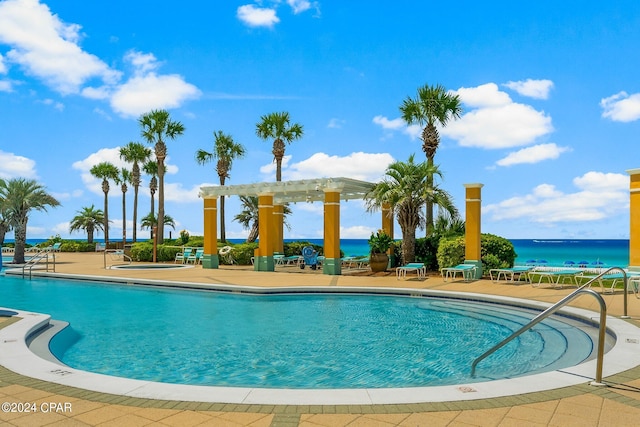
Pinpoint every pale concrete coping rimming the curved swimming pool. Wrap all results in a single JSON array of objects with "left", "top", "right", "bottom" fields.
[{"left": 0, "top": 273, "right": 640, "bottom": 405}]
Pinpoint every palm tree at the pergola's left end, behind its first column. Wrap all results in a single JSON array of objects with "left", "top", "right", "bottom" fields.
[{"left": 196, "top": 131, "right": 245, "bottom": 242}]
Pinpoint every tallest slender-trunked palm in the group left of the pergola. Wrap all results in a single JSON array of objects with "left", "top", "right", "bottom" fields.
[{"left": 138, "top": 110, "right": 184, "bottom": 243}]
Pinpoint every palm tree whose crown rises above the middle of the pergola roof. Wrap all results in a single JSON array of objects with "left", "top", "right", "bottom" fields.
[{"left": 256, "top": 112, "right": 303, "bottom": 182}]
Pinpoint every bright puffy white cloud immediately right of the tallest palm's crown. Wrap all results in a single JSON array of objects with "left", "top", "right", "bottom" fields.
[{"left": 440, "top": 83, "right": 553, "bottom": 149}]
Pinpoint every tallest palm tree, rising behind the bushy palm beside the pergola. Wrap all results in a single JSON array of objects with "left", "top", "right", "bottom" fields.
[{"left": 400, "top": 85, "right": 462, "bottom": 235}]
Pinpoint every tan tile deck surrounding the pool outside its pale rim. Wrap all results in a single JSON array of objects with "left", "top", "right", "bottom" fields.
[{"left": 0, "top": 253, "right": 640, "bottom": 426}]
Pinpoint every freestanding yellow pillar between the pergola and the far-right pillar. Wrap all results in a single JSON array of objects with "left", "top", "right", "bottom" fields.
[{"left": 464, "top": 184, "right": 483, "bottom": 279}]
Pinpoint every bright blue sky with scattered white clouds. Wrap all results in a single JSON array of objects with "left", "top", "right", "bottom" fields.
[{"left": 0, "top": 0, "right": 640, "bottom": 239}]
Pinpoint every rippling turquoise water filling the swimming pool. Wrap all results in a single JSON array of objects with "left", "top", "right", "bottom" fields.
[{"left": 0, "top": 276, "right": 596, "bottom": 388}]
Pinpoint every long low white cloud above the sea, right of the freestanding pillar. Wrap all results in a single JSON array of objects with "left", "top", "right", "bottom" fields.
[{"left": 483, "top": 172, "right": 629, "bottom": 224}]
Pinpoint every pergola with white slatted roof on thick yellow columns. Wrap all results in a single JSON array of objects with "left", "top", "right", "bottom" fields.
[{"left": 200, "top": 178, "right": 393, "bottom": 275}]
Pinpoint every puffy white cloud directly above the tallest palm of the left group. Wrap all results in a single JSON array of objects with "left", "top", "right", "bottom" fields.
[{"left": 107, "top": 52, "right": 201, "bottom": 117}]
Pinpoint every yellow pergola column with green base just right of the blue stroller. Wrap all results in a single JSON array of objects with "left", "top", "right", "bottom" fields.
[{"left": 322, "top": 190, "right": 342, "bottom": 275}]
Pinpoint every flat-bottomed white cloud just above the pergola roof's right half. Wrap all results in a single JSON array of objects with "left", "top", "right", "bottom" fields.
[{"left": 276, "top": 152, "right": 394, "bottom": 182}]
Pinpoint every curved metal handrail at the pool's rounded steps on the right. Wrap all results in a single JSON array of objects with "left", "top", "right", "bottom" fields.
[{"left": 471, "top": 267, "right": 628, "bottom": 386}]
